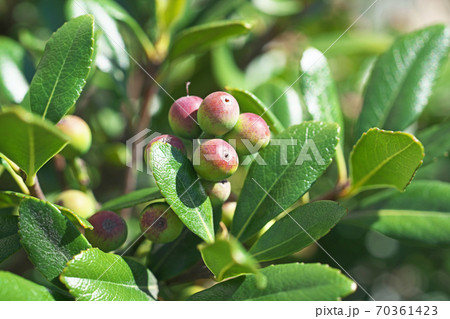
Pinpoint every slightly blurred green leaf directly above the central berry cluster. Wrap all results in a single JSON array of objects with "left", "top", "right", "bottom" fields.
[{"left": 169, "top": 21, "right": 252, "bottom": 59}]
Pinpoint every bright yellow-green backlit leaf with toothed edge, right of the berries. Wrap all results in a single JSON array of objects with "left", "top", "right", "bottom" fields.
[{"left": 349, "top": 128, "right": 425, "bottom": 193}]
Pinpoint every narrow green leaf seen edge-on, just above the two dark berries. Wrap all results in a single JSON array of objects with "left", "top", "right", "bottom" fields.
[{"left": 102, "top": 187, "right": 162, "bottom": 210}]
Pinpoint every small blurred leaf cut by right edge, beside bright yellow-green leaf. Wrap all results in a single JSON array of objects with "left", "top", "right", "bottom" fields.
[{"left": 417, "top": 122, "right": 450, "bottom": 166}]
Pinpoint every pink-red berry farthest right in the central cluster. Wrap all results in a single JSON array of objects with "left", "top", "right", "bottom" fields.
[{"left": 224, "top": 113, "right": 270, "bottom": 156}]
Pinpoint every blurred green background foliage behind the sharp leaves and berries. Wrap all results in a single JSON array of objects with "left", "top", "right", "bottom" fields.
[{"left": 0, "top": 0, "right": 450, "bottom": 300}]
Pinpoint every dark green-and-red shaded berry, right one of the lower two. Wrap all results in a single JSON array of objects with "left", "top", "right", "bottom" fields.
[{"left": 139, "top": 203, "right": 184, "bottom": 243}]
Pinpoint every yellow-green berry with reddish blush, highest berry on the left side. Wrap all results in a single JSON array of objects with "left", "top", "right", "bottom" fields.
[{"left": 56, "top": 115, "right": 92, "bottom": 159}]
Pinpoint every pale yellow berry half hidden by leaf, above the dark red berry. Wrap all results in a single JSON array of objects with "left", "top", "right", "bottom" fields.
[{"left": 55, "top": 189, "right": 96, "bottom": 218}]
